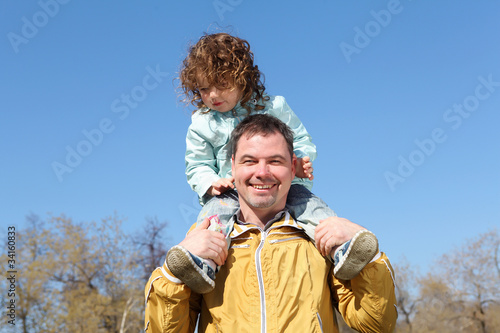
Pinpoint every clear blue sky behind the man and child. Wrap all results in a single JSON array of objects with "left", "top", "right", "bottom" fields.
[{"left": 0, "top": 0, "right": 500, "bottom": 269}]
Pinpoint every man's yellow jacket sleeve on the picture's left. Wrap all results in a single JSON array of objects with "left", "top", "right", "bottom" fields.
[{"left": 144, "top": 264, "right": 201, "bottom": 333}]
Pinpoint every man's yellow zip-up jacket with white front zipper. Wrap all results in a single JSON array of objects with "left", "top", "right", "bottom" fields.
[{"left": 145, "top": 213, "right": 397, "bottom": 333}]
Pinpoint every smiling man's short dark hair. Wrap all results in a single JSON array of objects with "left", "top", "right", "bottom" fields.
[{"left": 230, "top": 114, "right": 293, "bottom": 158}]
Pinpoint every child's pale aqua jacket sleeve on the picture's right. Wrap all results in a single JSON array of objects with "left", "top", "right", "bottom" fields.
[{"left": 270, "top": 96, "right": 317, "bottom": 161}]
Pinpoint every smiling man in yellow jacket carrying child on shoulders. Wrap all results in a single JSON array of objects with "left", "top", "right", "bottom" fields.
[{"left": 145, "top": 115, "right": 397, "bottom": 332}]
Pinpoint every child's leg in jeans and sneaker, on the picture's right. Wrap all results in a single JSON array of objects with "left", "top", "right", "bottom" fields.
[{"left": 287, "top": 184, "right": 378, "bottom": 280}]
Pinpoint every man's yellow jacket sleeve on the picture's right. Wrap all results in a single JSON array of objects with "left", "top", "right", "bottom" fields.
[{"left": 333, "top": 253, "right": 398, "bottom": 332}]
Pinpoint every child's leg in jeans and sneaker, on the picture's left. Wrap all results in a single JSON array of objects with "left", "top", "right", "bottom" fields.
[{"left": 167, "top": 190, "right": 239, "bottom": 294}]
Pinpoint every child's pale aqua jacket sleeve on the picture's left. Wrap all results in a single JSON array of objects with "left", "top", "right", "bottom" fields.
[{"left": 185, "top": 124, "right": 220, "bottom": 198}]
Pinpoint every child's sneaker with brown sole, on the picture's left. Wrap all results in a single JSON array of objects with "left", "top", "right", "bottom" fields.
[{"left": 167, "top": 245, "right": 215, "bottom": 294}]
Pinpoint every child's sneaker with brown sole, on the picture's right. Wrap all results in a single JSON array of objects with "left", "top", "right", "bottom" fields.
[{"left": 332, "top": 230, "right": 378, "bottom": 280}]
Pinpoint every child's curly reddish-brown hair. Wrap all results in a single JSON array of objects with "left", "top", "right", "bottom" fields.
[{"left": 179, "top": 33, "right": 265, "bottom": 113}]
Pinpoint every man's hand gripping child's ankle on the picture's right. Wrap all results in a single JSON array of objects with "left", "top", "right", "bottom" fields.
[{"left": 314, "top": 216, "right": 366, "bottom": 256}]
